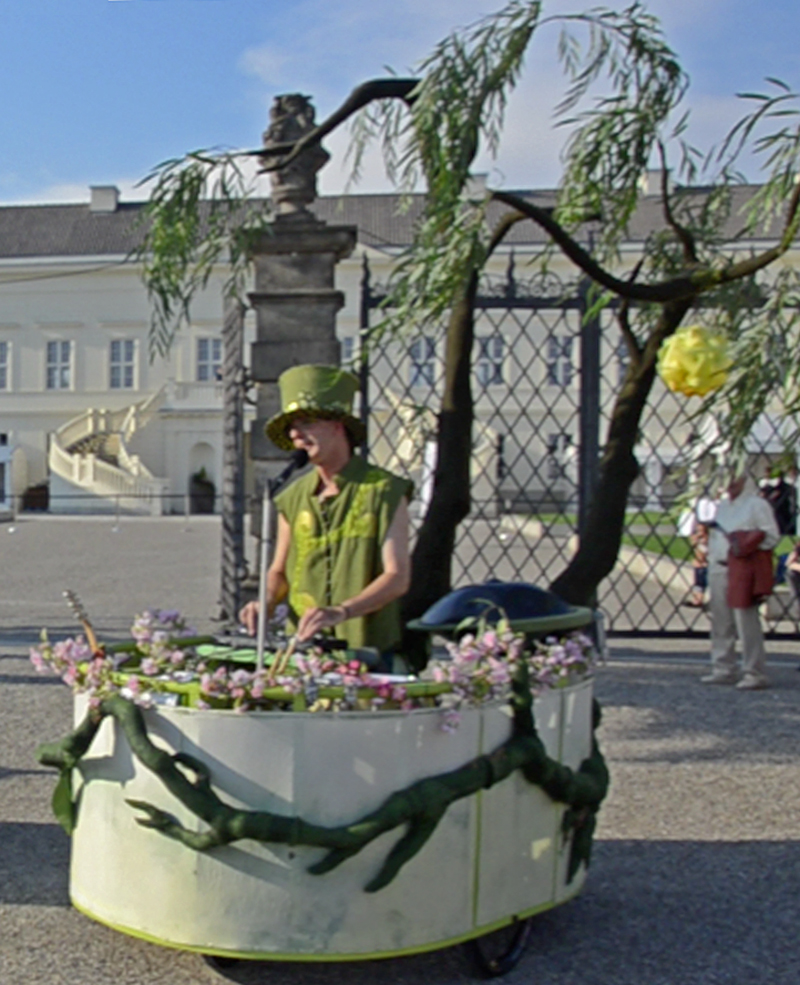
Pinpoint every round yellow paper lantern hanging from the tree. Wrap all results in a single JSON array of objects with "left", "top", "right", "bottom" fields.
[{"left": 657, "top": 325, "right": 732, "bottom": 397}]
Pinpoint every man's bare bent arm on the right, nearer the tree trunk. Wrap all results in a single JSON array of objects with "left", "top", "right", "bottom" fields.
[{"left": 297, "top": 497, "right": 411, "bottom": 640}]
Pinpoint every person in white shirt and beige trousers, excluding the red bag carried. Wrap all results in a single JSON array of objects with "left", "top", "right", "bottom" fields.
[{"left": 701, "top": 475, "right": 780, "bottom": 691}]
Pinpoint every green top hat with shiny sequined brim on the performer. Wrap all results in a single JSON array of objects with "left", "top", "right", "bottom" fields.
[{"left": 265, "top": 366, "right": 366, "bottom": 451}]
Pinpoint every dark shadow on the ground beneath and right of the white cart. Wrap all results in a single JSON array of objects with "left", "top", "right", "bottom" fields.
[{"left": 111, "top": 841, "right": 800, "bottom": 985}]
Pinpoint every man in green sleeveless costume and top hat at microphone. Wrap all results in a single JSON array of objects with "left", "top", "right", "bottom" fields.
[{"left": 240, "top": 366, "right": 413, "bottom": 654}]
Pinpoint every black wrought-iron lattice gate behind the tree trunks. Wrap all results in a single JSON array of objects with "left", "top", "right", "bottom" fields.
[{"left": 354, "top": 255, "right": 800, "bottom": 636}]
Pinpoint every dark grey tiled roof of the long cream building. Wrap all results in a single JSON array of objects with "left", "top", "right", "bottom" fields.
[{"left": 0, "top": 185, "right": 788, "bottom": 259}]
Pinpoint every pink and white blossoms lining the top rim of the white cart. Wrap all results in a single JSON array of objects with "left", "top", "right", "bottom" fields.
[{"left": 30, "top": 609, "right": 596, "bottom": 731}]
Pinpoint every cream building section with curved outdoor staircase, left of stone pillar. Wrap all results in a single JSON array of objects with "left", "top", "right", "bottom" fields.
[{"left": 0, "top": 187, "right": 253, "bottom": 513}]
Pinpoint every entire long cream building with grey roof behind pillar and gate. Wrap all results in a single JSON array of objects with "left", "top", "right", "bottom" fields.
[{"left": 0, "top": 181, "right": 795, "bottom": 513}]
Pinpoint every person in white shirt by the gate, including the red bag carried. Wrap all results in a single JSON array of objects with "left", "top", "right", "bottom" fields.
[{"left": 701, "top": 475, "right": 779, "bottom": 691}]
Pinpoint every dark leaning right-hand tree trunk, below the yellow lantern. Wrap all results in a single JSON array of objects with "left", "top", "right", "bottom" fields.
[{"left": 550, "top": 299, "right": 692, "bottom": 606}]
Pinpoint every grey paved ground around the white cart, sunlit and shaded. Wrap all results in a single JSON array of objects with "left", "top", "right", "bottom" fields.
[{"left": 0, "top": 518, "right": 800, "bottom": 985}]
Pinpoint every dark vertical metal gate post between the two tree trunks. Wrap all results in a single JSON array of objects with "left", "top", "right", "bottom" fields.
[{"left": 578, "top": 281, "right": 600, "bottom": 536}]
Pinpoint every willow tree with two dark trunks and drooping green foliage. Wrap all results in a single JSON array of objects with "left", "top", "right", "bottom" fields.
[{"left": 134, "top": 0, "right": 800, "bottom": 617}]
